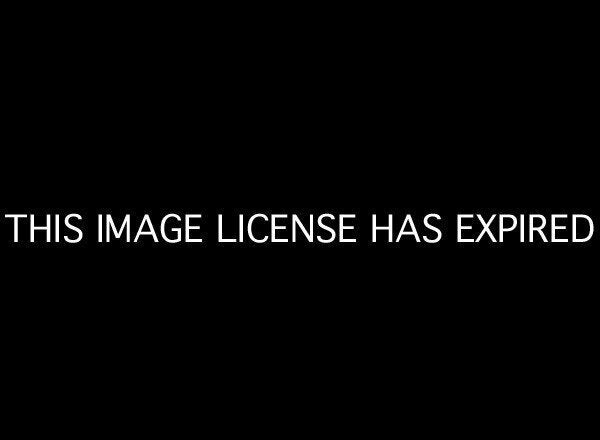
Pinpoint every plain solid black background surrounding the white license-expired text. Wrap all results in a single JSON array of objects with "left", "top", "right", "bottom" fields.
[{"left": 1, "top": 5, "right": 598, "bottom": 433}]
